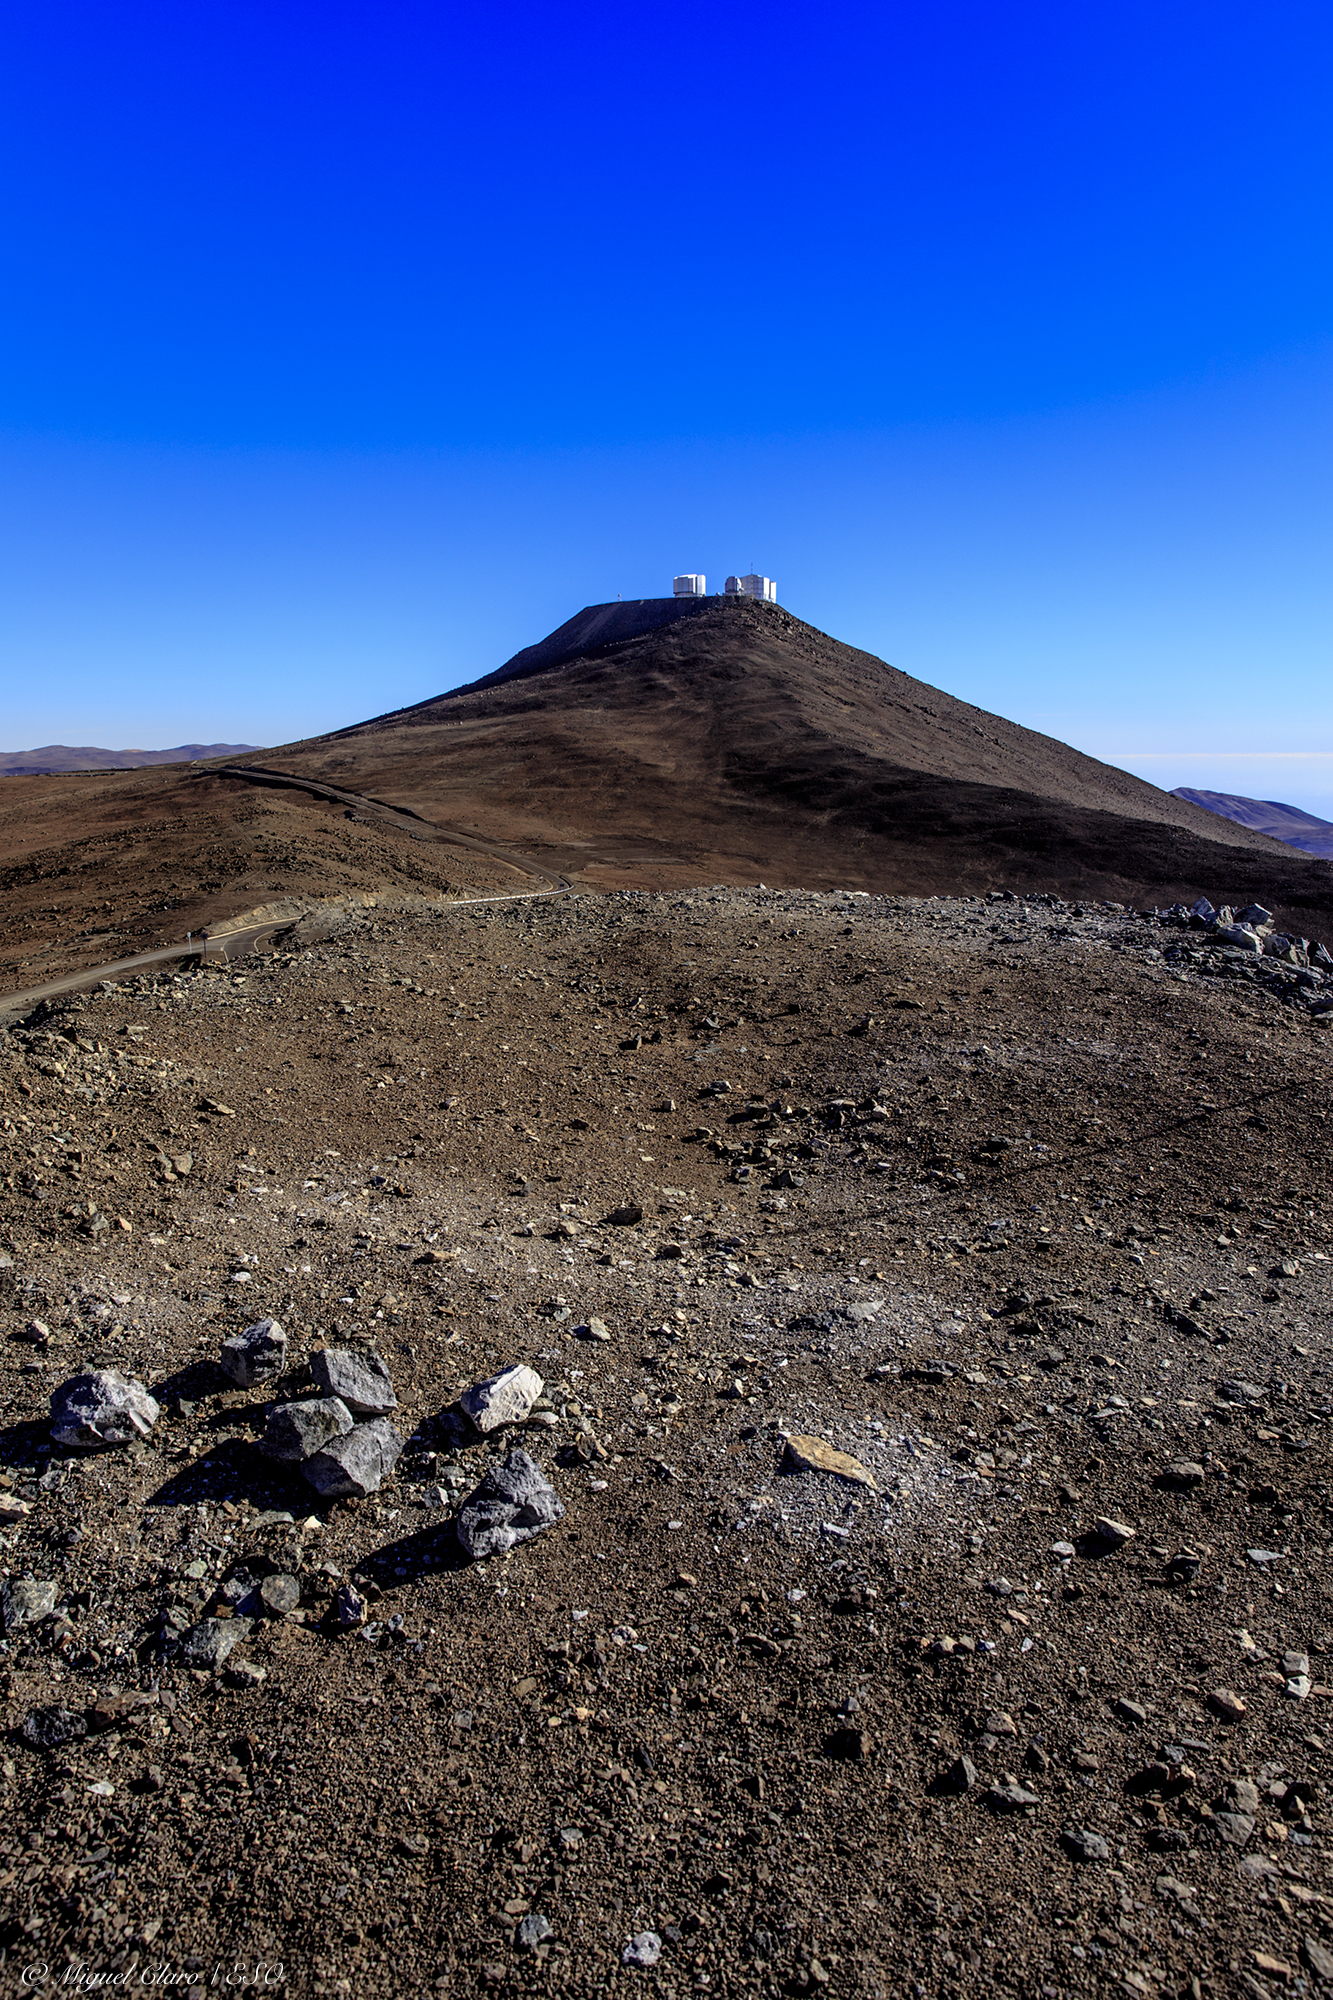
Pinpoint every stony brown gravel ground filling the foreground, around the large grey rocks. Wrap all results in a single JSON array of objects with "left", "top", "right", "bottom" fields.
[{"left": 0, "top": 882, "right": 1333, "bottom": 2000}]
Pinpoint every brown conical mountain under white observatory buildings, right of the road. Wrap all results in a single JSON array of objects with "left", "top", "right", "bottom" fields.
[{"left": 233, "top": 598, "right": 1333, "bottom": 912}]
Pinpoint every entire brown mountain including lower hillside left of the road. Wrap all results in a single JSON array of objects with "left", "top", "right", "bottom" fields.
[{"left": 0, "top": 598, "right": 1333, "bottom": 984}]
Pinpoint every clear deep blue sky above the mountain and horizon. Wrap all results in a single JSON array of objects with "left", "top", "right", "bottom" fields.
[{"left": 0, "top": 0, "right": 1333, "bottom": 818}]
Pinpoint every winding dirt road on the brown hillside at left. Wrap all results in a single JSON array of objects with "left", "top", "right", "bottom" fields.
[{"left": 0, "top": 764, "right": 574, "bottom": 1028}]
